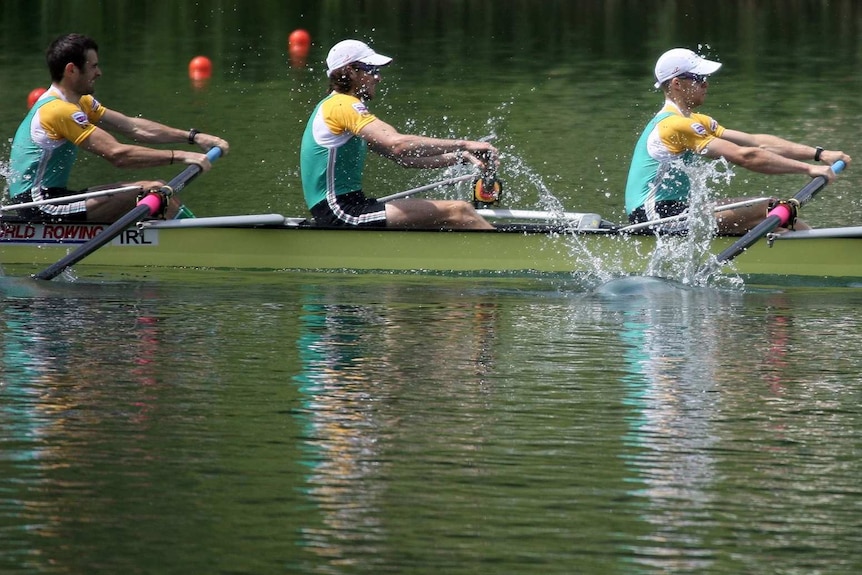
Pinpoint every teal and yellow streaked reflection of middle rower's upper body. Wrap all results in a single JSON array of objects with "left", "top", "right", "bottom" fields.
[{"left": 298, "top": 292, "right": 392, "bottom": 564}]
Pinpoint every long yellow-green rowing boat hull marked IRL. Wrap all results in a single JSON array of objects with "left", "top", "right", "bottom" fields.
[{"left": 0, "top": 210, "right": 862, "bottom": 284}]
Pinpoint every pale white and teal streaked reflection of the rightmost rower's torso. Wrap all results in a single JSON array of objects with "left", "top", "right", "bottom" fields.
[{"left": 615, "top": 284, "right": 721, "bottom": 571}]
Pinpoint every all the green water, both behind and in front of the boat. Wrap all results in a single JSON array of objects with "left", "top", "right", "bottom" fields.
[{"left": 0, "top": 0, "right": 862, "bottom": 575}]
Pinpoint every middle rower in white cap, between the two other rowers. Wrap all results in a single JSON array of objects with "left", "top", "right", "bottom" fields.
[{"left": 300, "top": 40, "right": 498, "bottom": 229}]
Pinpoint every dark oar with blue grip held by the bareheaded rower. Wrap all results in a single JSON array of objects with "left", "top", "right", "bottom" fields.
[{"left": 32, "top": 147, "right": 222, "bottom": 280}]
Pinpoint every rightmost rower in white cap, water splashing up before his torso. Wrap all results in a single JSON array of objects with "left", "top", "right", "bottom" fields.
[{"left": 626, "top": 48, "right": 850, "bottom": 235}]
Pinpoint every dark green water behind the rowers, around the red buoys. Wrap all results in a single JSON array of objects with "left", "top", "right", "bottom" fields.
[{"left": 0, "top": 0, "right": 862, "bottom": 225}]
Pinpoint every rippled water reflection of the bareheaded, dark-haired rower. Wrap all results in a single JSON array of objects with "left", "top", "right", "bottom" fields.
[{"left": 0, "top": 278, "right": 174, "bottom": 571}]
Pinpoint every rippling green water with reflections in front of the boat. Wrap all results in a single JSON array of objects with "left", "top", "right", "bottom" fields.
[{"left": 5, "top": 272, "right": 862, "bottom": 573}]
